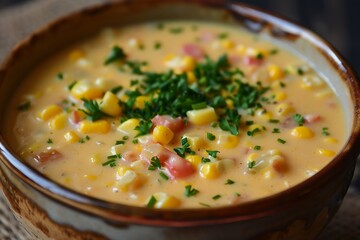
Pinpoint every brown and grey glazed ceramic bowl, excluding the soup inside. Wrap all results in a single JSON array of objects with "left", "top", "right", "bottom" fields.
[{"left": 0, "top": 0, "right": 360, "bottom": 240}]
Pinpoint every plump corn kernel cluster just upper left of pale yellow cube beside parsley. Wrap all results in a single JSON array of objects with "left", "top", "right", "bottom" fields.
[{"left": 70, "top": 80, "right": 103, "bottom": 99}]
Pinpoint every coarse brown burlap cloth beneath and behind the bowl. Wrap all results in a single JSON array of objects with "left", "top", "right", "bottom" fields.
[{"left": 0, "top": 0, "right": 360, "bottom": 240}]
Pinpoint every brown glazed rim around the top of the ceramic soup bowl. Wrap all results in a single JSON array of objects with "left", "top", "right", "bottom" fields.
[{"left": 0, "top": 0, "right": 360, "bottom": 227}]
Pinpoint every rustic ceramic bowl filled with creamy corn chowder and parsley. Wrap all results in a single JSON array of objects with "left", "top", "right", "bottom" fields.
[{"left": 0, "top": 0, "right": 360, "bottom": 239}]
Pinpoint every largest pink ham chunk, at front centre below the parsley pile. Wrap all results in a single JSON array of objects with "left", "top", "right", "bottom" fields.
[{"left": 140, "top": 144, "right": 195, "bottom": 179}]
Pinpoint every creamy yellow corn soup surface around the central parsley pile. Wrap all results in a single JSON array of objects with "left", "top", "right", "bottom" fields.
[{"left": 9, "top": 21, "right": 345, "bottom": 208}]
